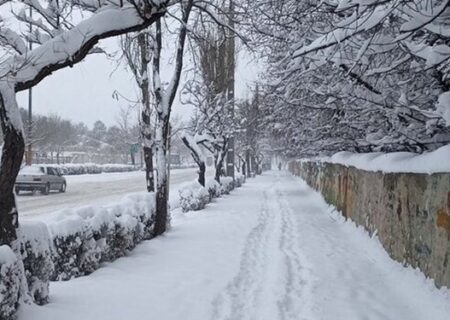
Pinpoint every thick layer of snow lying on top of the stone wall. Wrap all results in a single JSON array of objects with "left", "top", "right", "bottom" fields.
[{"left": 308, "top": 145, "right": 450, "bottom": 174}]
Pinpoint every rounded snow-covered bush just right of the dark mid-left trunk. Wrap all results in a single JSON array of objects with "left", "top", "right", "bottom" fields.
[{"left": 178, "top": 181, "right": 211, "bottom": 212}]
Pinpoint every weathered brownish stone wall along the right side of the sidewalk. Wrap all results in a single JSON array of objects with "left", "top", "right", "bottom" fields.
[{"left": 289, "top": 159, "right": 450, "bottom": 288}]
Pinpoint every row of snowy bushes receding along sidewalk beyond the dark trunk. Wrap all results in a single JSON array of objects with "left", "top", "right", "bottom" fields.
[{"left": 178, "top": 174, "right": 245, "bottom": 212}]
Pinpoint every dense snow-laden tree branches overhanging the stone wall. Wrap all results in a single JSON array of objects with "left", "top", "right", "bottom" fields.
[{"left": 243, "top": 0, "right": 450, "bottom": 156}]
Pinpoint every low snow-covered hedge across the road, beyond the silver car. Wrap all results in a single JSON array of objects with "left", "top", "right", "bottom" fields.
[{"left": 39, "top": 163, "right": 139, "bottom": 175}]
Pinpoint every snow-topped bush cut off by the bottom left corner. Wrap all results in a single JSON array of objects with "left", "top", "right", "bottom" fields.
[{"left": 0, "top": 246, "right": 23, "bottom": 320}]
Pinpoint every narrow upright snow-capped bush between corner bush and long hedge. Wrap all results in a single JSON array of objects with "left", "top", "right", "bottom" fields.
[{"left": 17, "top": 221, "right": 54, "bottom": 305}]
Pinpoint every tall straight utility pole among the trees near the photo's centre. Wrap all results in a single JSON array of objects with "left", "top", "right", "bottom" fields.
[{"left": 226, "top": 0, "right": 236, "bottom": 180}]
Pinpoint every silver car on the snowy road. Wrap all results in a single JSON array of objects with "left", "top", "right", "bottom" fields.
[{"left": 15, "top": 165, "right": 67, "bottom": 195}]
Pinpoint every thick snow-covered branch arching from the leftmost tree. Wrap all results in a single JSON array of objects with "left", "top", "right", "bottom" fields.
[{"left": 0, "top": 0, "right": 169, "bottom": 92}]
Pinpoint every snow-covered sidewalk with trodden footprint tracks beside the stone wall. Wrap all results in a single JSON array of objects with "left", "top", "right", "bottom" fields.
[{"left": 19, "top": 172, "right": 450, "bottom": 320}]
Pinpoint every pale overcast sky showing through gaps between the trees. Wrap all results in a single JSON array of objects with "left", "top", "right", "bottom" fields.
[{"left": 14, "top": 39, "right": 259, "bottom": 126}]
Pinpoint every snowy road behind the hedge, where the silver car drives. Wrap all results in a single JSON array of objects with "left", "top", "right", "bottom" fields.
[{"left": 16, "top": 169, "right": 202, "bottom": 218}]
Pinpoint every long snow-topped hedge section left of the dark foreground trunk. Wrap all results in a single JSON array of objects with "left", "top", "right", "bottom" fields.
[{"left": 50, "top": 194, "right": 155, "bottom": 280}]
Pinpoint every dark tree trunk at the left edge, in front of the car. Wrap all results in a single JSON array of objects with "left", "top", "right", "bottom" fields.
[{"left": 0, "top": 92, "right": 25, "bottom": 246}]
